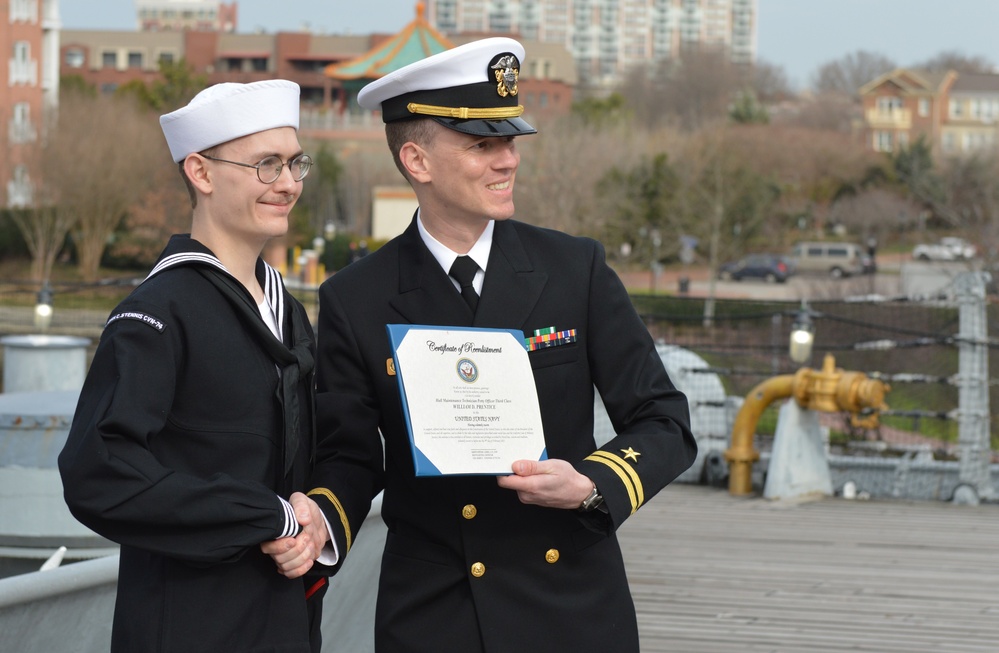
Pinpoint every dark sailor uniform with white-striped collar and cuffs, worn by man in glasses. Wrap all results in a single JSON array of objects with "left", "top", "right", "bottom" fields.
[{"left": 59, "top": 236, "right": 322, "bottom": 653}]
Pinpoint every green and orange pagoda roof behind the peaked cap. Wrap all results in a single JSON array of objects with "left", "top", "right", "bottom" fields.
[{"left": 325, "top": 2, "right": 454, "bottom": 80}]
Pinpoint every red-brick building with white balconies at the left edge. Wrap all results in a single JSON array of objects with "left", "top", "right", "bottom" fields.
[{"left": 0, "top": 0, "right": 59, "bottom": 208}]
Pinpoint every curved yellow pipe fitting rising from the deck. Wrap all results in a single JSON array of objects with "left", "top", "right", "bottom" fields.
[{"left": 725, "top": 354, "right": 891, "bottom": 495}]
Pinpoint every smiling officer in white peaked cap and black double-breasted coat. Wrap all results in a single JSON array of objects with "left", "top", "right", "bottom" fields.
[{"left": 316, "top": 38, "right": 696, "bottom": 653}]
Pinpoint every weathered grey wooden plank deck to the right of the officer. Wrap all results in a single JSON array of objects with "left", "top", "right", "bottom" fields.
[{"left": 619, "top": 484, "right": 999, "bottom": 653}]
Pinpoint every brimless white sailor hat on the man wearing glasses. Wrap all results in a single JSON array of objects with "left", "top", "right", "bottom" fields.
[{"left": 160, "top": 79, "right": 299, "bottom": 163}]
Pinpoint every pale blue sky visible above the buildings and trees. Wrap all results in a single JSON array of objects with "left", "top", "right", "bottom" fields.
[{"left": 60, "top": 0, "right": 999, "bottom": 88}]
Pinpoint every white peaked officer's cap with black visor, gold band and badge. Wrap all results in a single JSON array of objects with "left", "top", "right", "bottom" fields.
[{"left": 357, "top": 37, "right": 538, "bottom": 136}]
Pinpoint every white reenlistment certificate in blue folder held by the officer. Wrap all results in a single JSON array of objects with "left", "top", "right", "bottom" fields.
[{"left": 387, "top": 324, "right": 548, "bottom": 476}]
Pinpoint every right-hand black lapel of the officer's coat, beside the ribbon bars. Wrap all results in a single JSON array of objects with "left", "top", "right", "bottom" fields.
[{"left": 475, "top": 220, "right": 548, "bottom": 328}]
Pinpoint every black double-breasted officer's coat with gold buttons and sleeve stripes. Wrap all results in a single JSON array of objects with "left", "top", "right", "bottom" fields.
[{"left": 313, "top": 220, "right": 696, "bottom": 653}]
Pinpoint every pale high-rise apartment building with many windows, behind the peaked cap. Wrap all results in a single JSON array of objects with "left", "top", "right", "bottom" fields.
[{"left": 428, "top": 0, "right": 756, "bottom": 87}]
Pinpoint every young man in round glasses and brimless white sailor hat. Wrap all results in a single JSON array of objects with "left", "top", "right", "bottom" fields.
[{"left": 59, "top": 80, "right": 339, "bottom": 653}]
